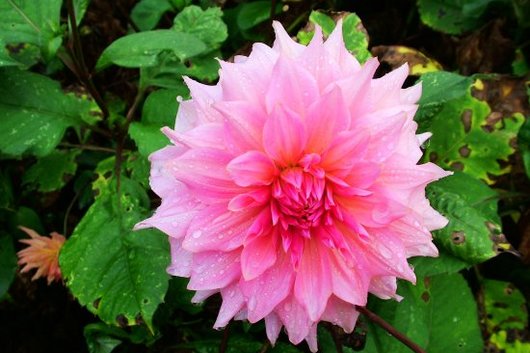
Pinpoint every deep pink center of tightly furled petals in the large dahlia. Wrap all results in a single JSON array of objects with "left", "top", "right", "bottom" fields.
[{"left": 271, "top": 167, "right": 333, "bottom": 234}]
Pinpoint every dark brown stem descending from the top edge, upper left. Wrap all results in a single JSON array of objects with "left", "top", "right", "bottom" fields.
[{"left": 63, "top": 0, "right": 109, "bottom": 118}]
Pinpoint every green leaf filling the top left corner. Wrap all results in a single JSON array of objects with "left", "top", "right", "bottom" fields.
[{"left": 0, "top": 0, "right": 62, "bottom": 61}]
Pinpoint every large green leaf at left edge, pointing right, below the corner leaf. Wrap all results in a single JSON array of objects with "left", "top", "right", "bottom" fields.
[{"left": 0, "top": 68, "right": 92, "bottom": 157}]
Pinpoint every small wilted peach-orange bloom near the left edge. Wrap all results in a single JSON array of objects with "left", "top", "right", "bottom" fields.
[{"left": 17, "top": 226, "right": 66, "bottom": 284}]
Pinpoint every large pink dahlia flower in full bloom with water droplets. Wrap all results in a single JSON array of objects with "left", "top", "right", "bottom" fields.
[{"left": 137, "top": 23, "right": 448, "bottom": 351}]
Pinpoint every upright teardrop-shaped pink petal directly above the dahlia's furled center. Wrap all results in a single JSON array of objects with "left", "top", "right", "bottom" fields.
[{"left": 263, "top": 106, "right": 307, "bottom": 166}]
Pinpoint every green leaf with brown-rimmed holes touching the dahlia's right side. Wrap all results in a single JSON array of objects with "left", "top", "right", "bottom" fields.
[{"left": 427, "top": 173, "right": 512, "bottom": 264}]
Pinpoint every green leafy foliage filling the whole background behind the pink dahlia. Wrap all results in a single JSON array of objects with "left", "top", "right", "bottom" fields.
[{"left": 0, "top": 0, "right": 530, "bottom": 353}]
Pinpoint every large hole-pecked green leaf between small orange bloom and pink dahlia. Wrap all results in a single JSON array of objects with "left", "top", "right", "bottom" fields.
[{"left": 59, "top": 177, "right": 169, "bottom": 331}]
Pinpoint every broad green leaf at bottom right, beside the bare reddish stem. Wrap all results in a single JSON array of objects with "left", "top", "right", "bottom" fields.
[{"left": 363, "top": 274, "right": 483, "bottom": 353}]
